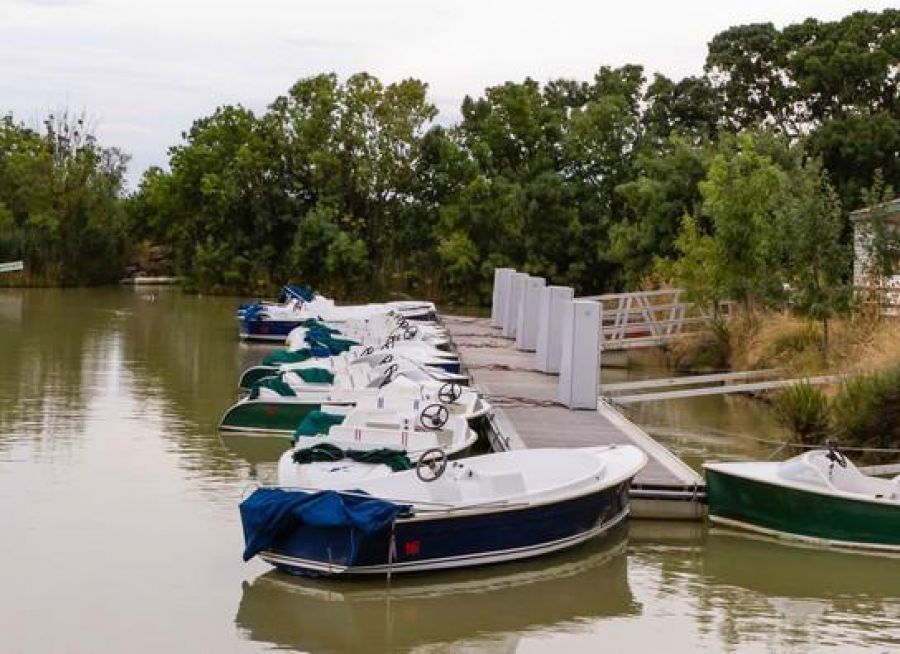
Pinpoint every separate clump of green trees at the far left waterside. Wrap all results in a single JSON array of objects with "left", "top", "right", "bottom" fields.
[{"left": 0, "top": 111, "right": 128, "bottom": 285}]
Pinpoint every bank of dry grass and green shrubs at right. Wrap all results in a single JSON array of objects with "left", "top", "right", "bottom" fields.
[{"left": 668, "top": 312, "right": 900, "bottom": 461}]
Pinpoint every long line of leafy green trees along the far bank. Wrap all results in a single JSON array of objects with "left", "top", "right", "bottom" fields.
[{"left": 0, "top": 10, "right": 900, "bottom": 302}]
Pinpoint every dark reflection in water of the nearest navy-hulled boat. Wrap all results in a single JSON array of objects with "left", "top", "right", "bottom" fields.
[{"left": 235, "top": 526, "right": 640, "bottom": 651}]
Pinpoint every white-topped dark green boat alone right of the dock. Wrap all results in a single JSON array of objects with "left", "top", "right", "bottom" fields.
[{"left": 704, "top": 449, "right": 900, "bottom": 552}]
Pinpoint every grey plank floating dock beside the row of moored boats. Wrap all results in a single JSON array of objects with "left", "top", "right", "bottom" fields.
[{"left": 442, "top": 316, "right": 705, "bottom": 519}]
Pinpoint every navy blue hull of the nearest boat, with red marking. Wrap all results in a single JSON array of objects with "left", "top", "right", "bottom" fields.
[{"left": 260, "top": 481, "right": 628, "bottom": 575}]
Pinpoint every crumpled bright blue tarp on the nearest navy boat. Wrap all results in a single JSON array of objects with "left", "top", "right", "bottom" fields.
[{"left": 241, "top": 488, "right": 409, "bottom": 561}]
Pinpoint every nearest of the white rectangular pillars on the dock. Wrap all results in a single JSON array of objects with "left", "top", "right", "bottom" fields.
[{"left": 559, "top": 301, "right": 602, "bottom": 410}]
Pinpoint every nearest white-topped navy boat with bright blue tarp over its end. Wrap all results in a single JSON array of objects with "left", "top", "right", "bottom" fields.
[{"left": 241, "top": 445, "right": 647, "bottom": 575}]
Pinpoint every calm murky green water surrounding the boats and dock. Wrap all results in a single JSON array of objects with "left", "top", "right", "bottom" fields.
[{"left": 0, "top": 289, "right": 900, "bottom": 654}]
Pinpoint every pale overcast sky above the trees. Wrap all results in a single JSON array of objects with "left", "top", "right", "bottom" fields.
[{"left": 0, "top": 0, "right": 892, "bottom": 180}]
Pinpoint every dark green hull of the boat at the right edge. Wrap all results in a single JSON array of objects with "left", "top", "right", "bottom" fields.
[{"left": 706, "top": 468, "right": 900, "bottom": 551}]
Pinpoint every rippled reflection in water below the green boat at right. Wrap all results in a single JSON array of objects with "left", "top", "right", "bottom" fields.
[{"left": 701, "top": 528, "right": 900, "bottom": 651}]
